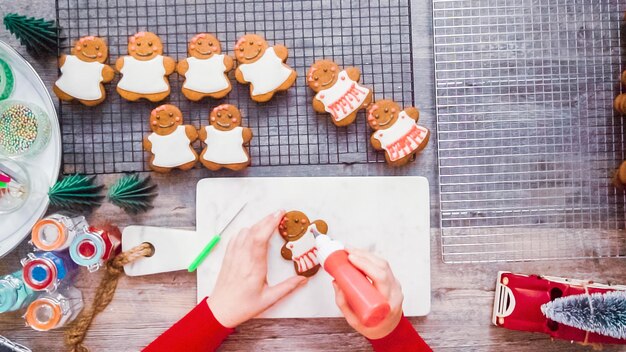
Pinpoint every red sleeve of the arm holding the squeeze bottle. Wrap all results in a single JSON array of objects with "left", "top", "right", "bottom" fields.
[{"left": 368, "top": 316, "right": 432, "bottom": 352}]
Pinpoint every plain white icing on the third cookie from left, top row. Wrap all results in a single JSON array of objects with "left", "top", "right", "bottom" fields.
[{"left": 183, "top": 54, "right": 228, "bottom": 94}]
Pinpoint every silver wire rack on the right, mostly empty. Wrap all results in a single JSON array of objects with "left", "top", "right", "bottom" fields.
[{"left": 433, "top": 0, "right": 626, "bottom": 263}]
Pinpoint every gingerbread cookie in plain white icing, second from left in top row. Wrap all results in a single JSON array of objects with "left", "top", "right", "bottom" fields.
[{"left": 115, "top": 32, "right": 176, "bottom": 102}]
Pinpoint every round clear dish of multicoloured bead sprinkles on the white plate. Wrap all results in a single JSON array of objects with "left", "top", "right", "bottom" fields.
[{"left": 0, "top": 100, "right": 50, "bottom": 157}]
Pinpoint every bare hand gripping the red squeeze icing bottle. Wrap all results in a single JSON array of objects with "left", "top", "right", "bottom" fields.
[{"left": 333, "top": 248, "right": 404, "bottom": 340}]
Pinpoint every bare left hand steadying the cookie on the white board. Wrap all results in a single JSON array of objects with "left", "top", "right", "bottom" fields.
[{"left": 207, "top": 210, "right": 307, "bottom": 328}]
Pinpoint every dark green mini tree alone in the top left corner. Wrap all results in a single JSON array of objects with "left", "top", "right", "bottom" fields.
[{"left": 3, "top": 13, "right": 63, "bottom": 55}]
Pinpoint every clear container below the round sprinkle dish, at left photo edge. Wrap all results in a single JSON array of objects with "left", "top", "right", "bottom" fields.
[{"left": 0, "top": 157, "right": 32, "bottom": 214}]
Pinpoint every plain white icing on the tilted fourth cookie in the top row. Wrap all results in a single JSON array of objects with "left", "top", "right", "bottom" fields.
[{"left": 239, "top": 47, "right": 293, "bottom": 95}]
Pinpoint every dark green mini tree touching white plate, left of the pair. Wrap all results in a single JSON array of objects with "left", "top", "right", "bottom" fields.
[{"left": 48, "top": 174, "right": 104, "bottom": 209}]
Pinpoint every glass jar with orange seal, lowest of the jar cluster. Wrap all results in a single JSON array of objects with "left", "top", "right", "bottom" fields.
[{"left": 24, "top": 286, "right": 83, "bottom": 331}]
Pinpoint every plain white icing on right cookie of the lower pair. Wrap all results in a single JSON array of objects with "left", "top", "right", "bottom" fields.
[{"left": 203, "top": 126, "right": 248, "bottom": 165}]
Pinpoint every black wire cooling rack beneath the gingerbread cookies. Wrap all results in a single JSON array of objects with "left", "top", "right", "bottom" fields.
[{"left": 56, "top": 0, "right": 413, "bottom": 174}]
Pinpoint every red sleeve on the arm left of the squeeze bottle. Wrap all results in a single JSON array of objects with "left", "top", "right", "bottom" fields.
[{"left": 143, "top": 298, "right": 235, "bottom": 352}]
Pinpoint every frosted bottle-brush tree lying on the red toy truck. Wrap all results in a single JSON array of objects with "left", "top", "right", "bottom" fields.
[{"left": 541, "top": 291, "right": 626, "bottom": 339}]
